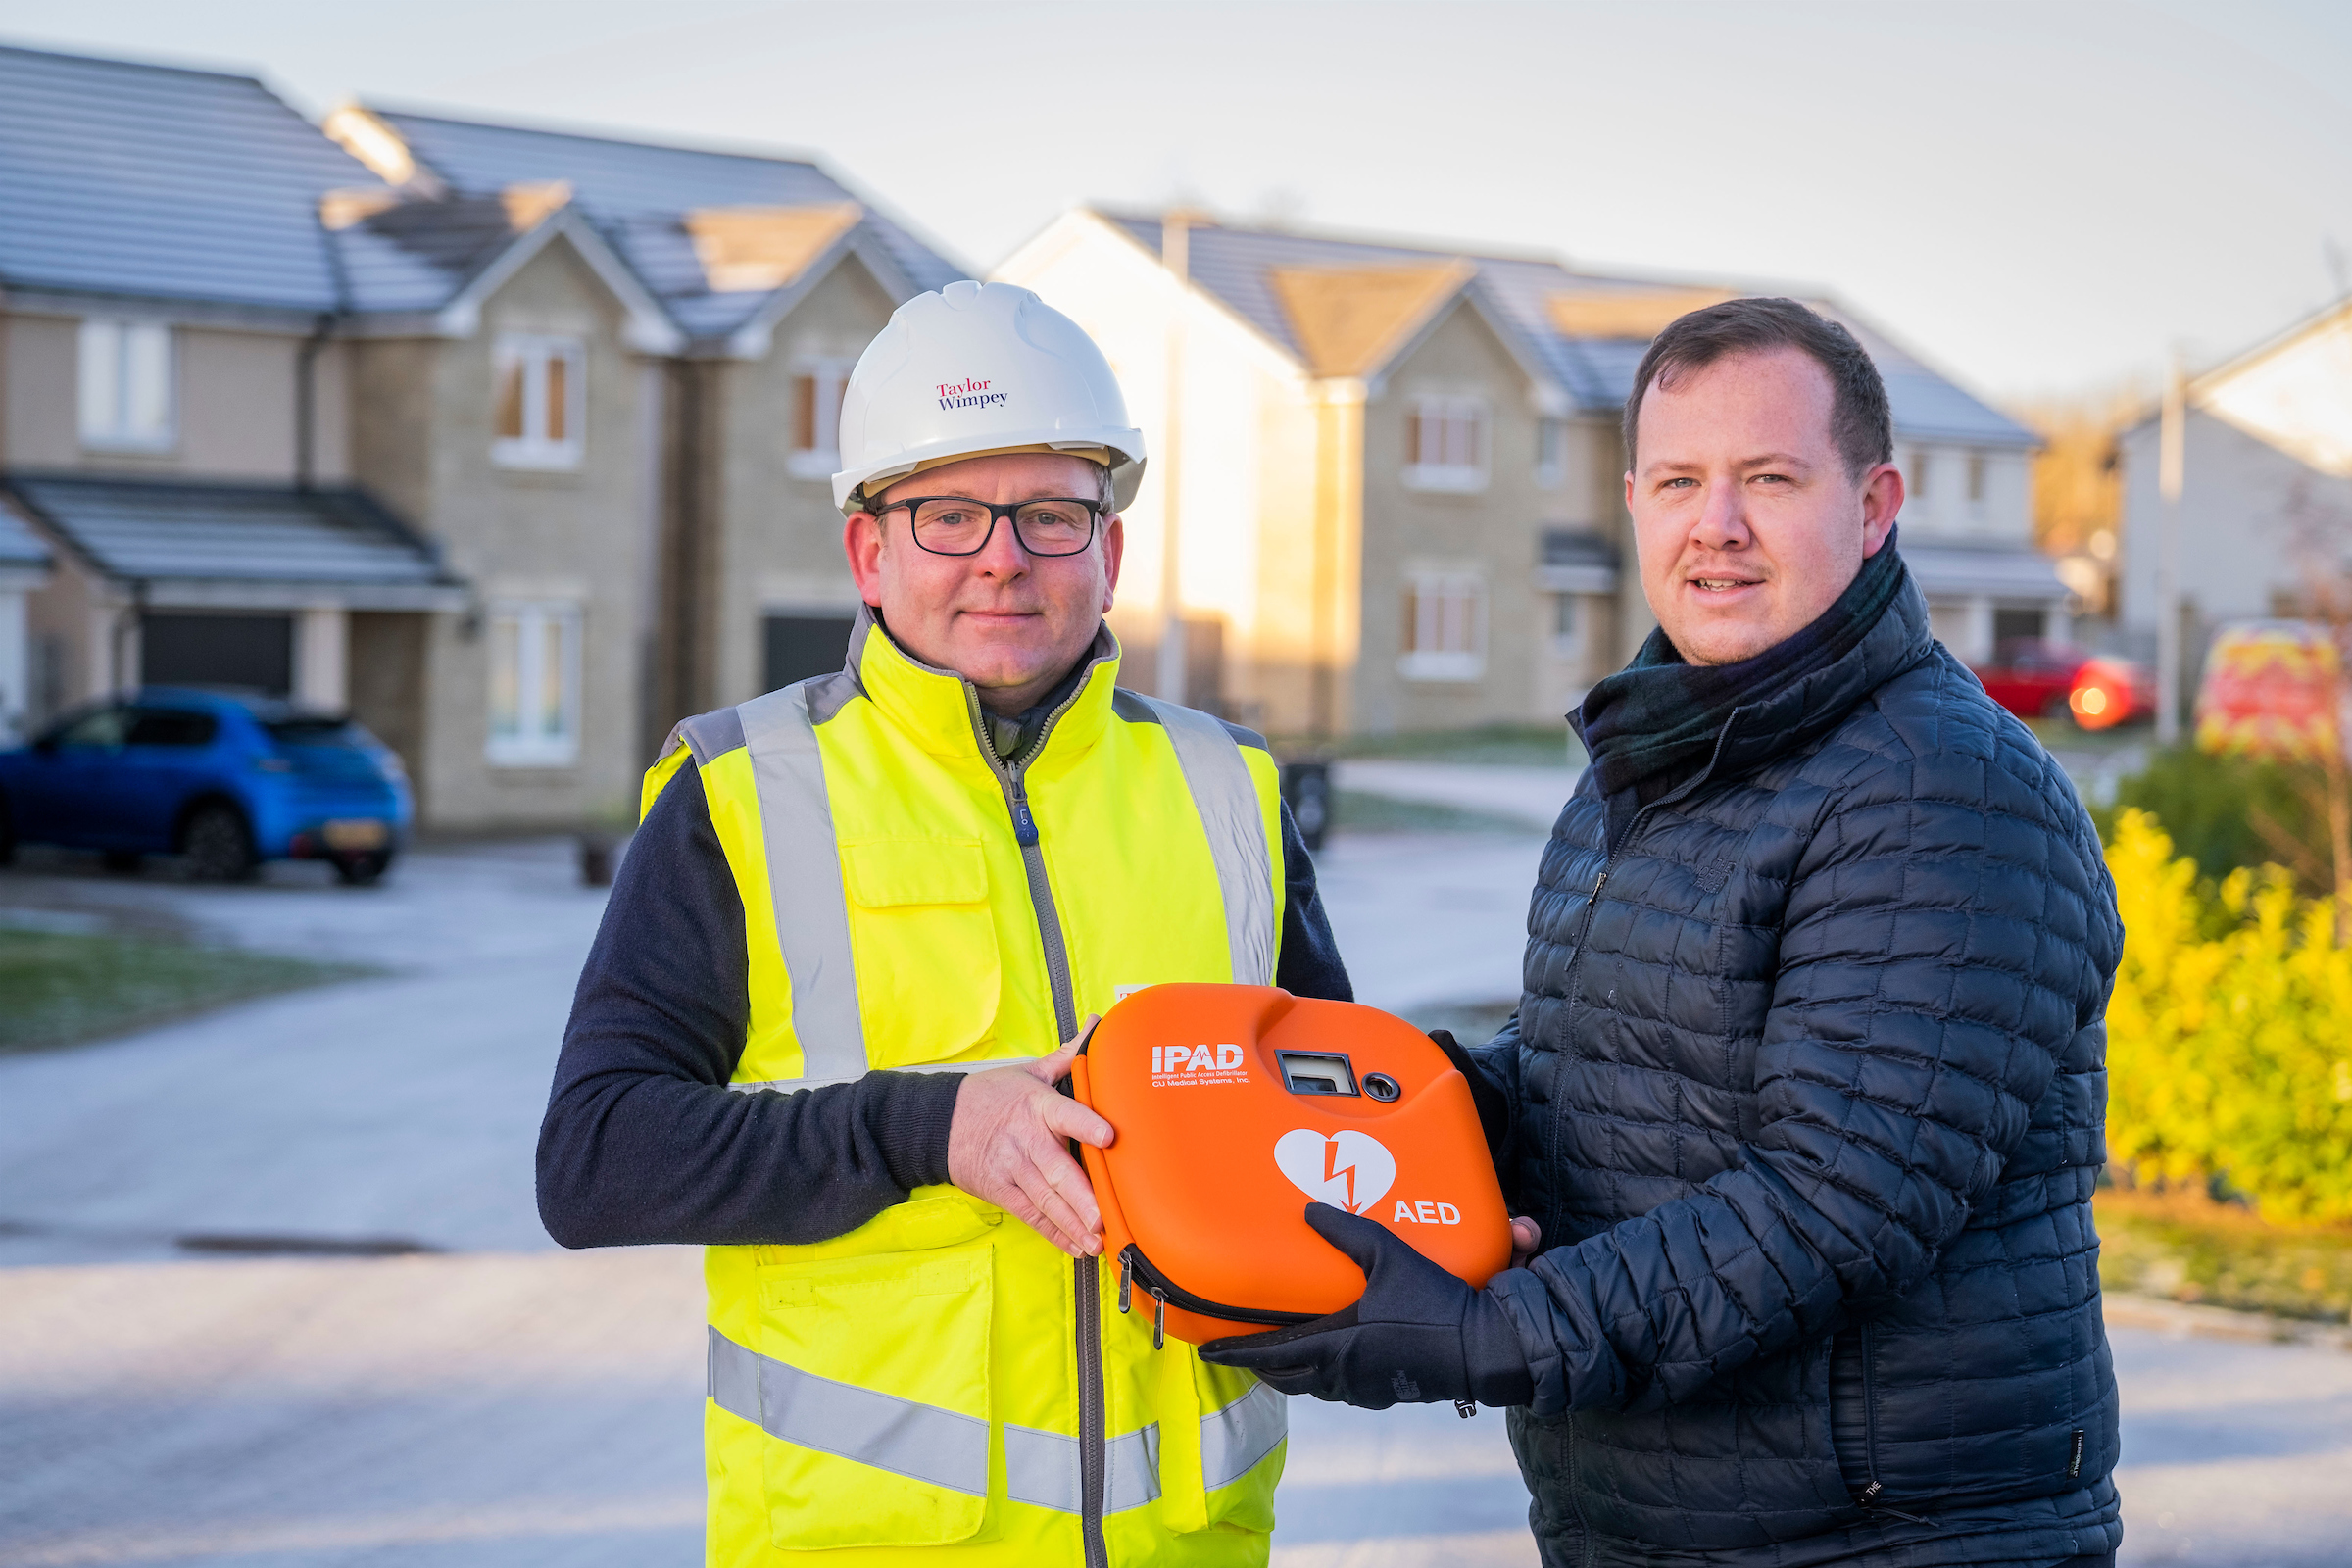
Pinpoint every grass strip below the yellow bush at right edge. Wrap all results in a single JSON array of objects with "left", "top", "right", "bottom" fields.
[{"left": 2091, "top": 1187, "right": 2352, "bottom": 1324}]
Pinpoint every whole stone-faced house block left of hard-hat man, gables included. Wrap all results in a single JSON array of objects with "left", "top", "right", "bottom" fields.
[{"left": 0, "top": 49, "right": 957, "bottom": 827}]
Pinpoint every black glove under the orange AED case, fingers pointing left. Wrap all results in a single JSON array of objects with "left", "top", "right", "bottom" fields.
[{"left": 1200, "top": 1203, "right": 1536, "bottom": 1410}]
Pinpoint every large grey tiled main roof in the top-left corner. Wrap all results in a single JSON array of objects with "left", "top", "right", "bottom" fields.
[{"left": 0, "top": 47, "right": 376, "bottom": 311}]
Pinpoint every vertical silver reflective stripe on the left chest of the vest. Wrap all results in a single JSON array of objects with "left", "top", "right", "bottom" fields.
[{"left": 736, "top": 677, "right": 865, "bottom": 1081}]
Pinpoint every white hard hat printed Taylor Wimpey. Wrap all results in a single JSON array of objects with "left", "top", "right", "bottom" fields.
[{"left": 833, "top": 279, "right": 1143, "bottom": 514}]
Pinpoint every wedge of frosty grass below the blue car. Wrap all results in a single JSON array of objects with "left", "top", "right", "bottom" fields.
[{"left": 0, "top": 929, "right": 374, "bottom": 1055}]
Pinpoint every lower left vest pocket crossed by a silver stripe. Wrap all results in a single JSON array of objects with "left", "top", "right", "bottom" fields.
[{"left": 758, "top": 1242, "right": 993, "bottom": 1551}]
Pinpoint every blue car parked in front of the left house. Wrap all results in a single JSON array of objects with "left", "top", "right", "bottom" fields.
[{"left": 0, "top": 686, "right": 412, "bottom": 882}]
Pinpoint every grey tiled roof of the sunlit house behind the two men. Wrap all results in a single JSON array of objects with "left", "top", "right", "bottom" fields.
[{"left": 1101, "top": 212, "right": 2039, "bottom": 447}]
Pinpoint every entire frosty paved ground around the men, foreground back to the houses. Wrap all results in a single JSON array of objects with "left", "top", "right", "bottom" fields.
[{"left": 0, "top": 835, "right": 2352, "bottom": 1568}]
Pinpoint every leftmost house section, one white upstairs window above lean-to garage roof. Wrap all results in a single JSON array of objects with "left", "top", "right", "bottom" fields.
[{"left": 0, "top": 49, "right": 466, "bottom": 789}]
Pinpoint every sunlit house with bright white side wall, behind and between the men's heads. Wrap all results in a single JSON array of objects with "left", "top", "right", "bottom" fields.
[{"left": 998, "top": 209, "right": 2065, "bottom": 736}]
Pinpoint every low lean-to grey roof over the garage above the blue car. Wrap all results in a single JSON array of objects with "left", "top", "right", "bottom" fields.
[{"left": 0, "top": 470, "right": 454, "bottom": 588}]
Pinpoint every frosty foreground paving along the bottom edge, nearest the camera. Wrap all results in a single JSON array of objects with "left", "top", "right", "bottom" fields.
[{"left": 0, "top": 1249, "right": 2352, "bottom": 1568}]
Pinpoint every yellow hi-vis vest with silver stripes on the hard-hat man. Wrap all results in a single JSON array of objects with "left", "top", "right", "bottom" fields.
[{"left": 645, "top": 615, "right": 1287, "bottom": 1568}]
